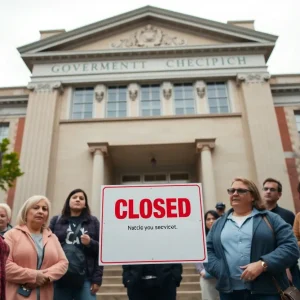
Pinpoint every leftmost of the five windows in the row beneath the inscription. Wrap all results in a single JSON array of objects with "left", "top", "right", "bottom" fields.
[{"left": 72, "top": 88, "right": 94, "bottom": 119}]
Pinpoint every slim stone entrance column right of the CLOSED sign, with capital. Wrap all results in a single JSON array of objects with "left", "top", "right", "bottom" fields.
[{"left": 196, "top": 139, "right": 217, "bottom": 211}]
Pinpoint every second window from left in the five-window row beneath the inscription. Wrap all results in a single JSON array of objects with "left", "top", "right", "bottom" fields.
[{"left": 106, "top": 86, "right": 127, "bottom": 118}]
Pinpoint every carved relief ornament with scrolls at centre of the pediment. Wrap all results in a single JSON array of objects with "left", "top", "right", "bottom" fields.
[{"left": 111, "top": 24, "right": 187, "bottom": 48}]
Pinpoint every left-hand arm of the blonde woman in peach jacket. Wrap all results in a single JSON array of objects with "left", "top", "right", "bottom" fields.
[{"left": 4, "top": 229, "right": 38, "bottom": 284}]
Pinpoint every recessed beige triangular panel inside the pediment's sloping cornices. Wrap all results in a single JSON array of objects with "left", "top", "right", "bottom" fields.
[{"left": 63, "top": 18, "right": 251, "bottom": 51}]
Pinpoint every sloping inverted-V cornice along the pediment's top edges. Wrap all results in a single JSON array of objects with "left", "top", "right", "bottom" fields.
[{"left": 18, "top": 6, "right": 277, "bottom": 54}]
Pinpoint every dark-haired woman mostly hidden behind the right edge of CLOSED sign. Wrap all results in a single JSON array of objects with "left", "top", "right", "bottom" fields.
[{"left": 196, "top": 210, "right": 220, "bottom": 300}]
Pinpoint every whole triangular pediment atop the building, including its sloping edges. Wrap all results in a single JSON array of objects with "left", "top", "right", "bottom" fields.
[{"left": 18, "top": 6, "right": 277, "bottom": 54}]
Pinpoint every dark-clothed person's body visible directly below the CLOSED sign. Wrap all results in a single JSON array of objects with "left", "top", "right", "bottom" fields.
[{"left": 123, "top": 264, "right": 182, "bottom": 300}]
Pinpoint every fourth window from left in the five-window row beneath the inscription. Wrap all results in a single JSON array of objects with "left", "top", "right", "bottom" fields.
[{"left": 174, "top": 83, "right": 196, "bottom": 115}]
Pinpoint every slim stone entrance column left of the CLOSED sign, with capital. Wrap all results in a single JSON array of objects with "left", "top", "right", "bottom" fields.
[{"left": 88, "top": 143, "right": 108, "bottom": 218}]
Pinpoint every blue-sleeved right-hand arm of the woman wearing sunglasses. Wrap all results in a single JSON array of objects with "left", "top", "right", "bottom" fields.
[{"left": 261, "top": 214, "right": 299, "bottom": 274}]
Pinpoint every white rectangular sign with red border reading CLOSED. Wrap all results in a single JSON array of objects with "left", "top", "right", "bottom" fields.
[{"left": 99, "top": 184, "right": 207, "bottom": 265}]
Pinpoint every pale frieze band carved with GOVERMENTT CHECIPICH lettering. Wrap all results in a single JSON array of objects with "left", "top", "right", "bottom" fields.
[{"left": 32, "top": 55, "right": 265, "bottom": 77}]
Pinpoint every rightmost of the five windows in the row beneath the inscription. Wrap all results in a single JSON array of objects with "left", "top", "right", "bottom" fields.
[{"left": 207, "top": 82, "right": 230, "bottom": 114}]
